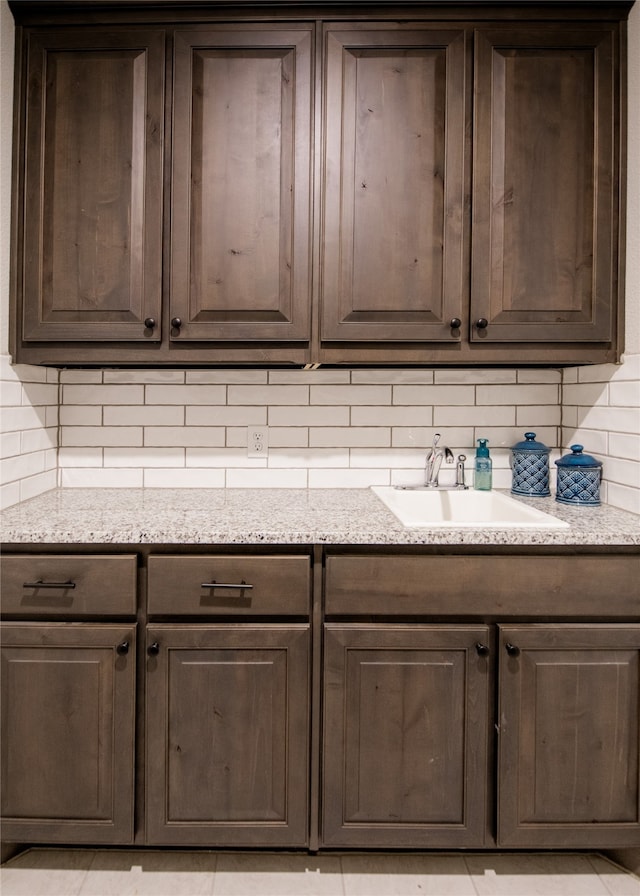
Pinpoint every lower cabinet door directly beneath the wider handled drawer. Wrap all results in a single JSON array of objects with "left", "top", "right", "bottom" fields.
[{"left": 146, "top": 624, "right": 309, "bottom": 847}]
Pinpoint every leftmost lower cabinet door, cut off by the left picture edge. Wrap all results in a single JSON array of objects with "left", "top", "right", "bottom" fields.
[{"left": 1, "top": 622, "right": 135, "bottom": 844}]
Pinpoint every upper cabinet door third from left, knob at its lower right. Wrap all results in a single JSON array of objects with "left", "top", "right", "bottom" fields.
[{"left": 321, "top": 23, "right": 468, "bottom": 342}]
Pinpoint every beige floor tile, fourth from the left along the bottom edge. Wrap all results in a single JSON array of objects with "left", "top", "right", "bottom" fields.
[{"left": 342, "top": 854, "right": 476, "bottom": 896}]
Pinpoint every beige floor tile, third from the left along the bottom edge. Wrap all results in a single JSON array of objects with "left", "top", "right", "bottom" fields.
[{"left": 213, "top": 854, "right": 344, "bottom": 896}]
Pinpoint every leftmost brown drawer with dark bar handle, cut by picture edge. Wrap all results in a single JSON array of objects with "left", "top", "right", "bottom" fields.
[{"left": 1, "top": 554, "right": 137, "bottom": 617}]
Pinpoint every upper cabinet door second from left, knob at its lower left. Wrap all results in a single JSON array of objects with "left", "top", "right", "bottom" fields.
[{"left": 170, "top": 23, "right": 313, "bottom": 342}]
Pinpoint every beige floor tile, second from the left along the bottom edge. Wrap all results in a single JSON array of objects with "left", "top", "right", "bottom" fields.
[{"left": 79, "top": 850, "right": 216, "bottom": 896}]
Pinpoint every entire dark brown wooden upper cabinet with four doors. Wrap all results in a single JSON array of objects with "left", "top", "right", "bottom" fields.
[{"left": 11, "top": 0, "right": 631, "bottom": 366}]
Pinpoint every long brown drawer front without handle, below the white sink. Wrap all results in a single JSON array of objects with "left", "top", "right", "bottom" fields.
[{"left": 325, "top": 554, "right": 640, "bottom": 618}]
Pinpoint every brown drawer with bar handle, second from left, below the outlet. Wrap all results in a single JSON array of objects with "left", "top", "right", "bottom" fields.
[{"left": 148, "top": 555, "right": 311, "bottom": 616}]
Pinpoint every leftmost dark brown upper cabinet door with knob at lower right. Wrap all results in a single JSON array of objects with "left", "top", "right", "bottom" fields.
[{"left": 19, "top": 28, "right": 164, "bottom": 342}]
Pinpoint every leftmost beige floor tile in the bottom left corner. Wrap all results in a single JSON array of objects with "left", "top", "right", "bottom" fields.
[{"left": 0, "top": 849, "right": 95, "bottom": 896}]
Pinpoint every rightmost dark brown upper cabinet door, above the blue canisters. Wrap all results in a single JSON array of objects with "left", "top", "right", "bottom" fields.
[{"left": 471, "top": 24, "right": 620, "bottom": 342}]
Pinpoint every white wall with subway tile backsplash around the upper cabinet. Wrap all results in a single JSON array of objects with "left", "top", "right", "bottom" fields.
[{"left": 0, "top": 0, "right": 640, "bottom": 512}]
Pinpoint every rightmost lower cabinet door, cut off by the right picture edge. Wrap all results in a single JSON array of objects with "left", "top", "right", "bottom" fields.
[{"left": 498, "top": 625, "right": 640, "bottom": 849}]
